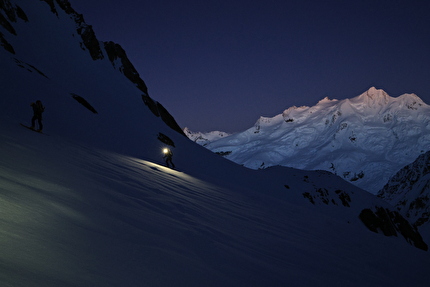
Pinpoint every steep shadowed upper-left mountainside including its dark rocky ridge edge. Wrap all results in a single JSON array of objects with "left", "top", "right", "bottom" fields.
[{"left": 0, "top": 0, "right": 183, "bottom": 148}]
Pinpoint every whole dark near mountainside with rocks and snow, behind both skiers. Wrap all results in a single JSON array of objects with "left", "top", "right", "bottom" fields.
[{"left": 0, "top": 0, "right": 430, "bottom": 287}]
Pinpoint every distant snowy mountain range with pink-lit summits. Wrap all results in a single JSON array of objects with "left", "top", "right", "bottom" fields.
[{"left": 206, "top": 87, "right": 430, "bottom": 194}]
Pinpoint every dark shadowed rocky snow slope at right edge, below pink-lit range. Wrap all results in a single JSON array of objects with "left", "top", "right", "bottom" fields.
[{"left": 378, "top": 151, "right": 430, "bottom": 232}]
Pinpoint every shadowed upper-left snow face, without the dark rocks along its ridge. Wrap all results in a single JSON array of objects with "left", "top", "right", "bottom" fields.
[{"left": 0, "top": 0, "right": 181, "bottom": 159}]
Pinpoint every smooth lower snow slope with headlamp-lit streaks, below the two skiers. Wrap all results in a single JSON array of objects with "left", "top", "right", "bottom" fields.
[{"left": 0, "top": 118, "right": 430, "bottom": 287}]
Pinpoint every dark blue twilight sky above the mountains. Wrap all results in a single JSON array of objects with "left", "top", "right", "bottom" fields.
[{"left": 70, "top": 0, "right": 430, "bottom": 132}]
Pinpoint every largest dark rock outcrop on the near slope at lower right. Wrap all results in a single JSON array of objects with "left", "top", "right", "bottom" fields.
[{"left": 359, "top": 206, "right": 428, "bottom": 251}]
